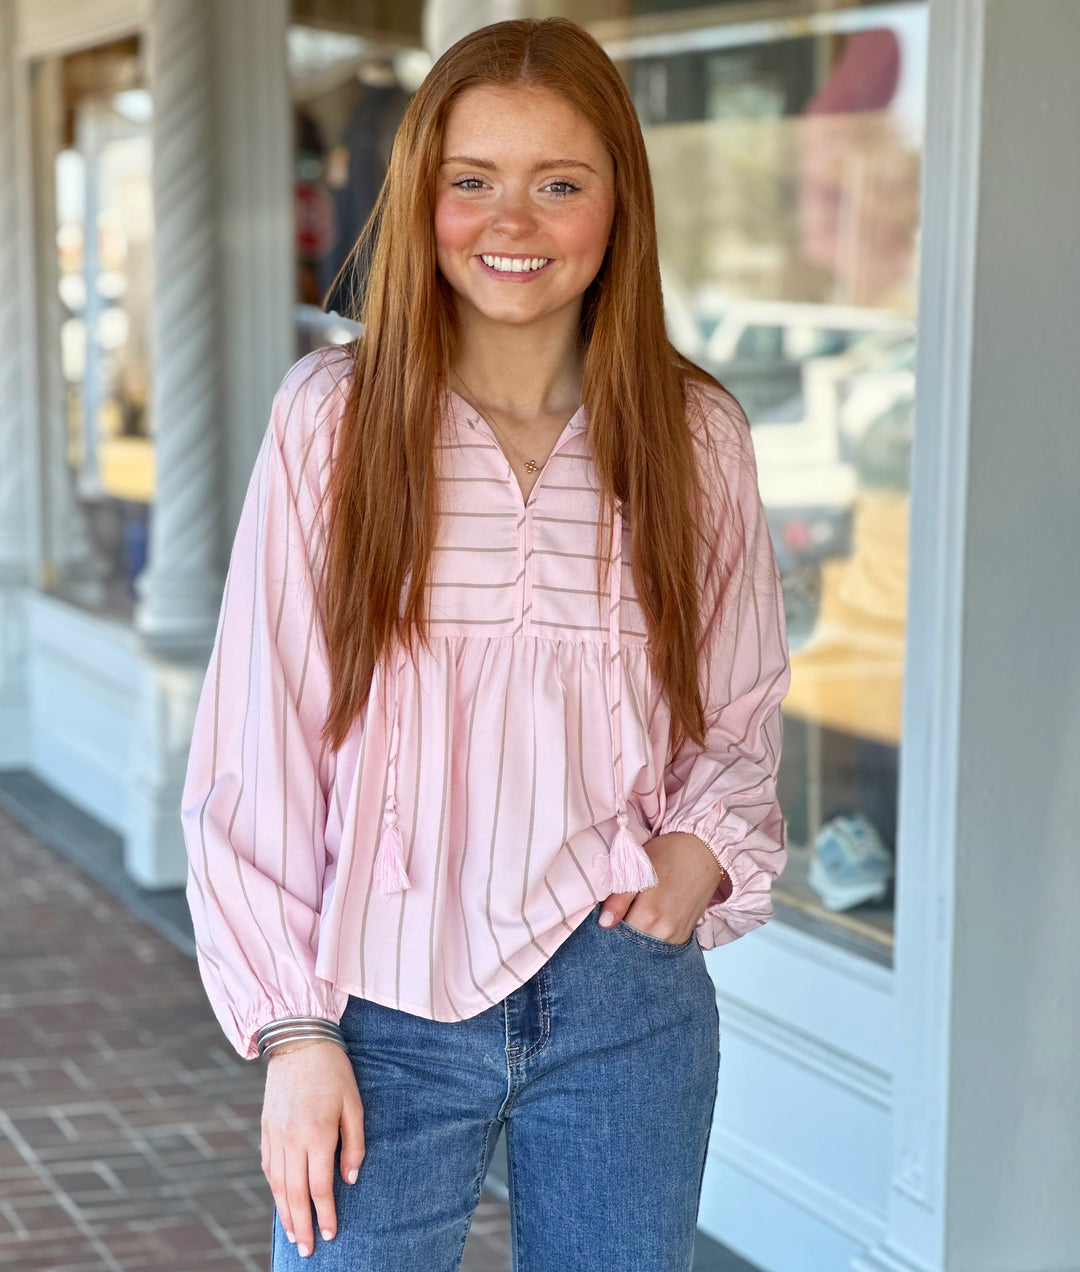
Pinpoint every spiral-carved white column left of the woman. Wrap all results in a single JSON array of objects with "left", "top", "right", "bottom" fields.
[{"left": 135, "top": 0, "right": 223, "bottom": 647}]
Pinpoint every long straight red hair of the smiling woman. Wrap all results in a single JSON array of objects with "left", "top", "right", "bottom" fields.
[{"left": 311, "top": 18, "right": 723, "bottom": 749}]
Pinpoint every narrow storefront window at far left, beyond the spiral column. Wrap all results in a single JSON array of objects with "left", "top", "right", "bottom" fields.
[{"left": 34, "top": 38, "right": 154, "bottom": 617}]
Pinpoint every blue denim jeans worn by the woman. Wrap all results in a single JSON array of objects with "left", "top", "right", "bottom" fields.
[{"left": 272, "top": 904, "right": 720, "bottom": 1272}]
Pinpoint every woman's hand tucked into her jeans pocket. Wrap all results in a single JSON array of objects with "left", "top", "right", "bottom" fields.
[{"left": 600, "top": 831, "right": 730, "bottom": 945}]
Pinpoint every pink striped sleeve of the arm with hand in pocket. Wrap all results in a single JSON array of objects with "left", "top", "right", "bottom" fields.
[{"left": 656, "top": 381, "right": 790, "bottom": 949}]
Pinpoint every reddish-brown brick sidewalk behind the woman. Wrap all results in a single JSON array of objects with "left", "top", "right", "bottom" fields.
[{"left": 0, "top": 813, "right": 509, "bottom": 1272}]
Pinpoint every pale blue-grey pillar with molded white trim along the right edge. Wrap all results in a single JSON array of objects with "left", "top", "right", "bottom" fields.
[{"left": 854, "top": 0, "right": 1080, "bottom": 1272}]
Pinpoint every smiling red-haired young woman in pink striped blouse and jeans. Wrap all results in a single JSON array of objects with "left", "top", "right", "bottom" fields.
[{"left": 183, "top": 12, "right": 789, "bottom": 1272}]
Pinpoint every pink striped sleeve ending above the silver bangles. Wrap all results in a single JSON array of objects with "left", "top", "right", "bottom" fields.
[{"left": 181, "top": 355, "right": 347, "bottom": 1060}]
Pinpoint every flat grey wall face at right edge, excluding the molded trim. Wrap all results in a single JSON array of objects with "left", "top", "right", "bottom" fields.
[{"left": 951, "top": 0, "right": 1080, "bottom": 1272}]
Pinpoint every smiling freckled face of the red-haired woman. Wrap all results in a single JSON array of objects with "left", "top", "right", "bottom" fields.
[{"left": 435, "top": 85, "right": 614, "bottom": 326}]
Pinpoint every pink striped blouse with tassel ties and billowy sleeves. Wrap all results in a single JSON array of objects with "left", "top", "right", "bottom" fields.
[{"left": 181, "top": 350, "right": 789, "bottom": 1058}]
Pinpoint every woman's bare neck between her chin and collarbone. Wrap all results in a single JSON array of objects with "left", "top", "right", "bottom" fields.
[{"left": 452, "top": 302, "right": 584, "bottom": 424}]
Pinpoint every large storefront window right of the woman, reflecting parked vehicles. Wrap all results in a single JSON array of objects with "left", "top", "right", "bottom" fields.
[{"left": 592, "top": 3, "right": 926, "bottom": 962}]
